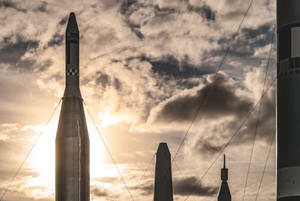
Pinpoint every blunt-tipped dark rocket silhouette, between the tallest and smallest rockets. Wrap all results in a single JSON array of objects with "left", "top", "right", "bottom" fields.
[{"left": 154, "top": 143, "right": 173, "bottom": 201}]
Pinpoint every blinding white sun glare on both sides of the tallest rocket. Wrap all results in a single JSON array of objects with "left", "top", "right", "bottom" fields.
[{"left": 27, "top": 119, "right": 122, "bottom": 197}]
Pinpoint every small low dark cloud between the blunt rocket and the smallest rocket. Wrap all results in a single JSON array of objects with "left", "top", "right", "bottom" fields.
[{"left": 174, "top": 177, "right": 218, "bottom": 196}]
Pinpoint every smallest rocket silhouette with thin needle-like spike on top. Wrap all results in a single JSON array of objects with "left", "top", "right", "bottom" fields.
[{"left": 218, "top": 155, "right": 231, "bottom": 201}]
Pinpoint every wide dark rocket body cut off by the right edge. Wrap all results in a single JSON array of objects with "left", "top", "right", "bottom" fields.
[{"left": 277, "top": 0, "right": 300, "bottom": 201}]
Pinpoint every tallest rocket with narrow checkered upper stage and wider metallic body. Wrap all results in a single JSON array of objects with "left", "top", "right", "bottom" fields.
[{"left": 55, "top": 13, "right": 90, "bottom": 201}]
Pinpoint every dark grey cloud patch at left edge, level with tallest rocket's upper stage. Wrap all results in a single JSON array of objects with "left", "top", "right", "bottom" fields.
[{"left": 0, "top": 37, "right": 39, "bottom": 70}]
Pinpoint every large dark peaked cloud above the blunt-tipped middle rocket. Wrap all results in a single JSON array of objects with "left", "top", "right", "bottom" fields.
[{"left": 152, "top": 73, "right": 252, "bottom": 122}]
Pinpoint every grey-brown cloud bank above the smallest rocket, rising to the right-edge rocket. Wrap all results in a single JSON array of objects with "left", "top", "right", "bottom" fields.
[{"left": 192, "top": 77, "right": 276, "bottom": 157}]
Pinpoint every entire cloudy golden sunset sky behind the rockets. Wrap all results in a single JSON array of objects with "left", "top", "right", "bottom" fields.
[{"left": 0, "top": 0, "right": 276, "bottom": 201}]
